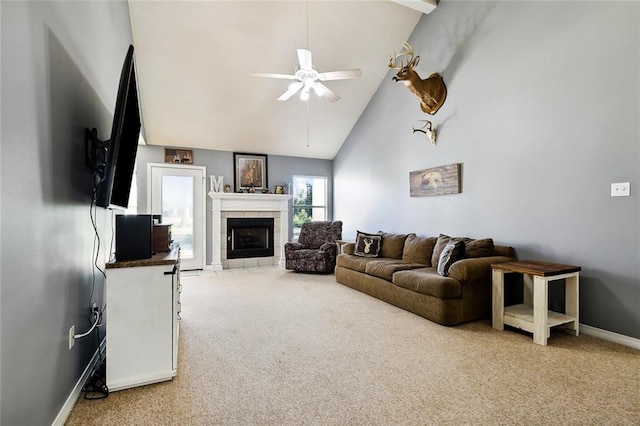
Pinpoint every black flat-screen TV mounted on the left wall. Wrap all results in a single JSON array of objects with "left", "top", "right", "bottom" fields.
[{"left": 96, "top": 46, "right": 141, "bottom": 209}]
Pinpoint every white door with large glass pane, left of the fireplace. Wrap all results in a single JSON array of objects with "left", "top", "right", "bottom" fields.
[{"left": 147, "top": 163, "right": 206, "bottom": 270}]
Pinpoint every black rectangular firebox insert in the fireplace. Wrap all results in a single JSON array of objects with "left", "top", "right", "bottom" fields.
[{"left": 227, "top": 217, "right": 274, "bottom": 259}]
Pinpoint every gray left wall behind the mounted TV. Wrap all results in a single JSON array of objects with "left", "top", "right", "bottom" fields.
[{"left": 0, "top": 1, "right": 132, "bottom": 425}]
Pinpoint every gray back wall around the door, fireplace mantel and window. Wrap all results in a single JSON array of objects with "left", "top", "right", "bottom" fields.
[{"left": 136, "top": 145, "right": 333, "bottom": 265}]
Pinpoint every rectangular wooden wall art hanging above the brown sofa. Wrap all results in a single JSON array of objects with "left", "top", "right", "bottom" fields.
[{"left": 409, "top": 163, "right": 461, "bottom": 197}]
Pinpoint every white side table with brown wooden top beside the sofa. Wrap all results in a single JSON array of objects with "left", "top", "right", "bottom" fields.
[{"left": 491, "top": 260, "right": 582, "bottom": 346}]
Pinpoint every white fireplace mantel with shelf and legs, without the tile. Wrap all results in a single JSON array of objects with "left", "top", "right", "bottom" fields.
[{"left": 209, "top": 191, "right": 292, "bottom": 271}]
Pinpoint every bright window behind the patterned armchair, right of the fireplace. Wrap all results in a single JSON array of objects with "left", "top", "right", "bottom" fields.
[{"left": 293, "top": 176, "right": 327, "bottom": 241}]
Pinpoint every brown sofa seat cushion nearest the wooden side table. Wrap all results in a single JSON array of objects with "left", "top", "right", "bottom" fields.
[{"left": 393, "top": 268, "right": 462, "bottom": 299}]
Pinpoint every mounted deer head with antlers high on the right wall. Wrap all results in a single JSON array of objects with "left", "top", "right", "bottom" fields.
[{"left": 387, "top": 43, "right": 447, "bottom": 115}]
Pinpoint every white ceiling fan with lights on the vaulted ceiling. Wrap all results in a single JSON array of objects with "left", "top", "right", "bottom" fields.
[{"left": 251, "top": 49, "right": 362, "bottom": 102}]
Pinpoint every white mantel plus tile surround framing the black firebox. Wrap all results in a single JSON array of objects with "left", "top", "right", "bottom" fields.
[{"left": 208, "top": 192, "right": 291, "bottom": 271}]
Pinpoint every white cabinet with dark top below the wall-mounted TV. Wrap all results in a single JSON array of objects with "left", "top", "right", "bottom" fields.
[{"left": 105, "top": 250, "right": 180, "bottom": 391}]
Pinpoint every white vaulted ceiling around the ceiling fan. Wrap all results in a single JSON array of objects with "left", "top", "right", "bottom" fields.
[{"left": 129, "top": 0, "right": 432, "bottom": 159}]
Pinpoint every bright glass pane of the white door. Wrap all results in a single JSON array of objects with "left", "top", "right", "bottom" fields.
[{"left": 162, "top": 176, "right": 194, "bottom": 259}]
